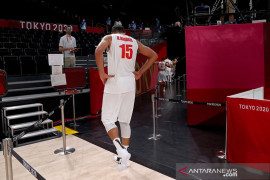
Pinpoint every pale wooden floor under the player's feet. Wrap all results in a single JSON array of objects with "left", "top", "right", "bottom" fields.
[{"left": 0, "top": 135, "right": 171, "bottom": 180}]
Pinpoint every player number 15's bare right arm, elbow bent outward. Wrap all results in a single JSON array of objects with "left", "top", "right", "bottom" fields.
[{"left": 134, "top": 41, "right": 158, "bottom": 80}]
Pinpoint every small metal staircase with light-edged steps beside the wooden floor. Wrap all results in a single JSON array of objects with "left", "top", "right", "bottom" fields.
[{"left": 2, "top": 103, "right": 61, "bottom": 146}]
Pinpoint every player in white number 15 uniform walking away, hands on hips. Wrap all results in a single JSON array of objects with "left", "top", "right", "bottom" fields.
[{"left": 95, "top": 25, "right": 157, "bottom": 171}]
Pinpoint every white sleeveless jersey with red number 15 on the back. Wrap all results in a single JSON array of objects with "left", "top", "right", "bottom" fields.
[{"left": 104, "top": 34, "right": 138, "bottom": 94}]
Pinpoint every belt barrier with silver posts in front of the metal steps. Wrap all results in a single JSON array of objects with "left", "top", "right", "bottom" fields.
[{"left": 2, "top": 95, "right": 75, "bottom": 180}]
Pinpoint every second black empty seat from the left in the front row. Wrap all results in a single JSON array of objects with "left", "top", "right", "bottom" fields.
[{"left": 19, "top": 56, "right": 37, "bottom": 75}]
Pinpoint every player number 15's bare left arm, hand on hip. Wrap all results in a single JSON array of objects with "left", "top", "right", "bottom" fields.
[{"left": 95, "top": 35, "right": 114, "bottom": 84}]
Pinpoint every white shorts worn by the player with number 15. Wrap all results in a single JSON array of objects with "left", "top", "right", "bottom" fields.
[{"left": 101, "top": 91, "right": 135, "bottom": 124}]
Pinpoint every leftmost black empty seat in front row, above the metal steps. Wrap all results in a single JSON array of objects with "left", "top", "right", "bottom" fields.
[{"left": 3, "top": 56, "right": 21, "bottom": 76}]
